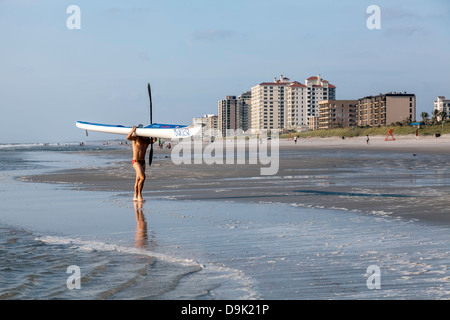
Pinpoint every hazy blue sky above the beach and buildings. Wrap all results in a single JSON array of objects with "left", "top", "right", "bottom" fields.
[{"left": 0, "top": 0, "right": 450, "bottom": 143}]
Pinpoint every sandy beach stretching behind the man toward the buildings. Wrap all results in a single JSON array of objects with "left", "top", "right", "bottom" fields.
[{"left": 21, "top": 135, "right": 450, "bottom": 224}]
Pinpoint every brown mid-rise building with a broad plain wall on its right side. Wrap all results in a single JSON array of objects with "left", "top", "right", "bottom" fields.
[{"left": 356, "top": 92, "right": 416, "bottom": 127}]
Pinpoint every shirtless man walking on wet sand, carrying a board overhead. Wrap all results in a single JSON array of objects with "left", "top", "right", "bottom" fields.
[{"left": 127, "top": 126, "right": 156, "bottom": 201}]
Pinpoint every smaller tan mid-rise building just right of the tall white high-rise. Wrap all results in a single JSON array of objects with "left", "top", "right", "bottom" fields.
[{"left": 317, "top": 100, "right": 358, "bottom": 129}]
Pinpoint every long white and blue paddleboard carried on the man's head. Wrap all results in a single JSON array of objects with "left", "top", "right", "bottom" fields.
[{"left": 76, "top": 121, "right": 201, "bottom": 139}]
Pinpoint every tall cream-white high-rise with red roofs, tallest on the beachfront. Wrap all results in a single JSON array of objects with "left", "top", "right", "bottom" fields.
[{"left": 251, "top": 75, "right": 336, "bottom": 132}]
